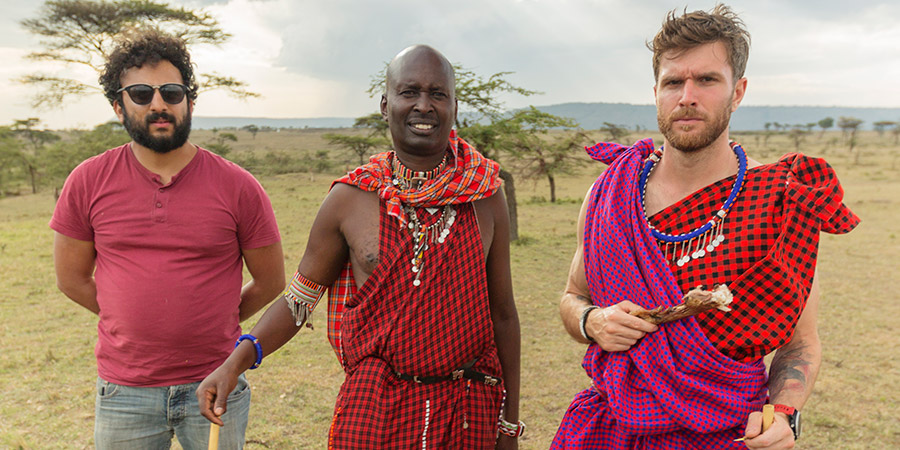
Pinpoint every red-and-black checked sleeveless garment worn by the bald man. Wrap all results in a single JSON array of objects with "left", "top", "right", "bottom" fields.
[{"left": 329, "top": 202, "right": 503, "bottom": 449}]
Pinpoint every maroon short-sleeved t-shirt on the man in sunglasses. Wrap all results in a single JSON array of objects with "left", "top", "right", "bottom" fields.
[{"left": 50, "top": 144, "right": 281, "bottom": 386}]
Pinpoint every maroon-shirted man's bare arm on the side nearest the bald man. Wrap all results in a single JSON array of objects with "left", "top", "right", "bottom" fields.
[{"left": 240, "top": 242, "right": 284, "bottom": 322}]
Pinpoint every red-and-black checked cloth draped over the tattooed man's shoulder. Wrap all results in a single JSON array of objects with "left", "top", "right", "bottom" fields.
[{"left": 650, "top": 154, "right": 859, "bottom": 362}]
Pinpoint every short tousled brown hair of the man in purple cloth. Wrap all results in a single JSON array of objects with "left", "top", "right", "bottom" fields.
[{"left": 647, "top": 3, "right": 750, "bottom": 81}]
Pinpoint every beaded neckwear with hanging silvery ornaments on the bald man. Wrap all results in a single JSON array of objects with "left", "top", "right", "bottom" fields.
[{"left": 391, "top": 154, "right": 456, "bottom": 286}]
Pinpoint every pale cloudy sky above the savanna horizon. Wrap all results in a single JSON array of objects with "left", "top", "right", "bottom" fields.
[{"left": 0, "top": 0, "right": 900, "bottom": 128}]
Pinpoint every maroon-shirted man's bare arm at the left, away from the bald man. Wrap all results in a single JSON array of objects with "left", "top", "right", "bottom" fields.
[{"left": 53, "top": 232, "right": 100, "bottom": 314}]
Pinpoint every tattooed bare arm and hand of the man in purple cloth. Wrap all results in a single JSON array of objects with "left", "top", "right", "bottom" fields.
[{"left": 745, "top": 274, "right": 822, "bottom": 448}]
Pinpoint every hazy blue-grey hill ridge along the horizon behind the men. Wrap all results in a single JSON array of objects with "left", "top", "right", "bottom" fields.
[{"left": 192, "top": 103, "right": 900, "bottom": 131}]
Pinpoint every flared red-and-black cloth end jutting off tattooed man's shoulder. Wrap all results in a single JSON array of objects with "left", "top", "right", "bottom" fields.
[{"left": 779, "top": 153, "right": 859, "bottom": 234}]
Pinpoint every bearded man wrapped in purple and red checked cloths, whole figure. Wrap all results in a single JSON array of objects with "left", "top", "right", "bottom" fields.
[{"left": 552, "top": 5, "right": 858, "bottom": 449}]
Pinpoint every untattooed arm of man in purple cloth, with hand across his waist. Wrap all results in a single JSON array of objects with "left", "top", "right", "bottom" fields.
[{"left": 559, "top": 190, "right": 658, "bottom": 352}]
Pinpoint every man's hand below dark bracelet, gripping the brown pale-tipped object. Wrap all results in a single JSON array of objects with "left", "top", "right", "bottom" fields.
[{"left": 584, "top": 301, "right": 659, "bottom": 352}]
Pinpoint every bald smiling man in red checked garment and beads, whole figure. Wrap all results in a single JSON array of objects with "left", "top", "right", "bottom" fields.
[{"left": 197, "top": 46, "right": 524, "bottom": 449}]
